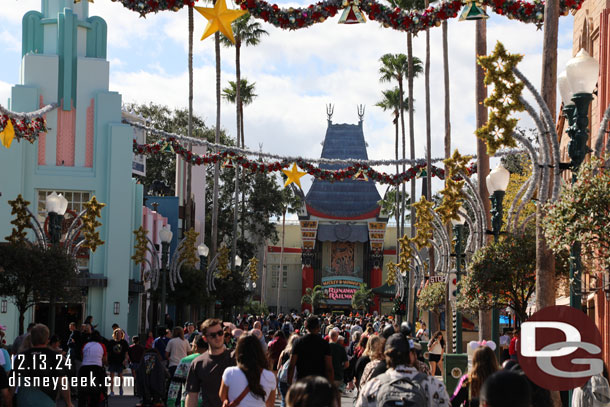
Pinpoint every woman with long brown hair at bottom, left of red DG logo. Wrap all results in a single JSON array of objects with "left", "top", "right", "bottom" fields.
[{"left": 451, "top": 346, "right": 500, "bottom": 407}]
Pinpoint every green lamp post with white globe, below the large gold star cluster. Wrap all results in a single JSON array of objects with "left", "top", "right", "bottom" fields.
[{"left": 485, "top": 164, "right": 510, "bottom": 356}]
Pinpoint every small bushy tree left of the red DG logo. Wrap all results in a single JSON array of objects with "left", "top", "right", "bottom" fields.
[{"left": 458, "top": 231, "right": 567, "bottom": 322}]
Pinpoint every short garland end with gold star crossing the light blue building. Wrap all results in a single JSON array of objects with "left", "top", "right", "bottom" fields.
[{"left": 0, "top": 103, "right": 58, "bottom": 148}]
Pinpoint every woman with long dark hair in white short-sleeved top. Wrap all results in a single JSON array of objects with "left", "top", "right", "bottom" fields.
[{"left": 219, "top": 335, "right": 276, "bottom": 407}]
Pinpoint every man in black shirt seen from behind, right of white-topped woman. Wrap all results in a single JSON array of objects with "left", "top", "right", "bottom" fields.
[{"left": 288, "top": 315, "right": 335, "bottom": 387}]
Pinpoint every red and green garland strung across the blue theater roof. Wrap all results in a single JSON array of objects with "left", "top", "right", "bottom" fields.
[{"left": 133, "top": 137, "right": 475, "bottom": 185}]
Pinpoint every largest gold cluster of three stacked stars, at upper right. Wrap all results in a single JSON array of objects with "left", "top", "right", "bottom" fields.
[{"left": 475, "top": 42, "right": 525, "bottom": 155}]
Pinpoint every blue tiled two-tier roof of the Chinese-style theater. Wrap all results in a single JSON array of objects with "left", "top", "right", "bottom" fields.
[{"left": 305, "top": 122, "right": 381, "bottom": 218}]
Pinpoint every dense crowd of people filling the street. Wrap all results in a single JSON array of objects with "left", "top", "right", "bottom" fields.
[{"left": 0, "top": 315, "right": 610, "bottom": 407}]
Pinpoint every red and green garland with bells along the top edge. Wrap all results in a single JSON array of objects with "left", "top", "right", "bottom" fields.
[{"left": 237, "top": 0, "right": 584, "bottom": 34}]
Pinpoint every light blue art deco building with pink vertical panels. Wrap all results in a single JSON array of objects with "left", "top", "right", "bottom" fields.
[{"left": 0, "top": 0, "right": 143, "bottom": 343}]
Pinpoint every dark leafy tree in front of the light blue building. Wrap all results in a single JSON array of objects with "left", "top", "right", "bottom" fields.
[{"left": 0, "top": 243, "right": 80, "bottom": 335}]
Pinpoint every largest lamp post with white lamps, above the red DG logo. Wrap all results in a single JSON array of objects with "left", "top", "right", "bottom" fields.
[{"left": 557, "top": 49, "right": 599, "bottom": 309}]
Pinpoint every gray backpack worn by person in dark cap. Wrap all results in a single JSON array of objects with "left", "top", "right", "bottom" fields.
[{"left": 376, "top": 373, "right": 428, "bottom": 407}]
